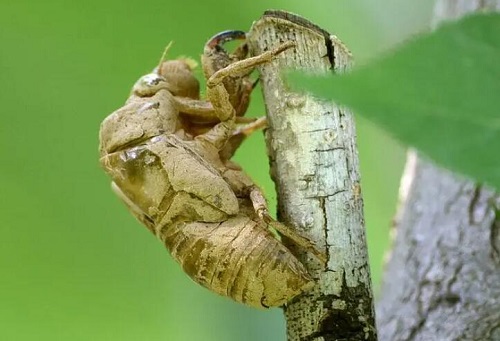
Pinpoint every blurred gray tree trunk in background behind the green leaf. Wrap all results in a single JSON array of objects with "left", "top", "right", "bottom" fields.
[{"left": 377, "top": 0, "right": 500, "bottom": 341}]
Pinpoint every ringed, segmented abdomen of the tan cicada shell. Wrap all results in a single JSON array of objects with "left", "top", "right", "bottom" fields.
[{"left": 160, "top": 215, "right": 312, "bottom": 308}]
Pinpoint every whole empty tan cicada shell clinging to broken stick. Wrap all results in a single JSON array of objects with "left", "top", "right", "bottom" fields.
[{"left": 100, "top": 31, "right": 324, "bottom": 307}]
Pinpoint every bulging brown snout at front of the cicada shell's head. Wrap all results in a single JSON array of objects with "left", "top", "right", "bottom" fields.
[{"left": 158, "top": 58, "right": 200, "bottom": 99}]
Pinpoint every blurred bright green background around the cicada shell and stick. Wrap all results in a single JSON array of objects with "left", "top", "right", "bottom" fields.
[{"left": 0, "top": 0, "right": 433, "bottom": 341}]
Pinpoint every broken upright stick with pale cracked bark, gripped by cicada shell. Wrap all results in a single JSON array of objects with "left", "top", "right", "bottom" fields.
[{"left": 248, "top": 12, "right": 377, "bottom": 341}]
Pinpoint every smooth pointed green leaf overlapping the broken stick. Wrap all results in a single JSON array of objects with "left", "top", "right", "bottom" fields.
[{"left": 291, "top": 14, "right": 500, "bottom": 189}]
